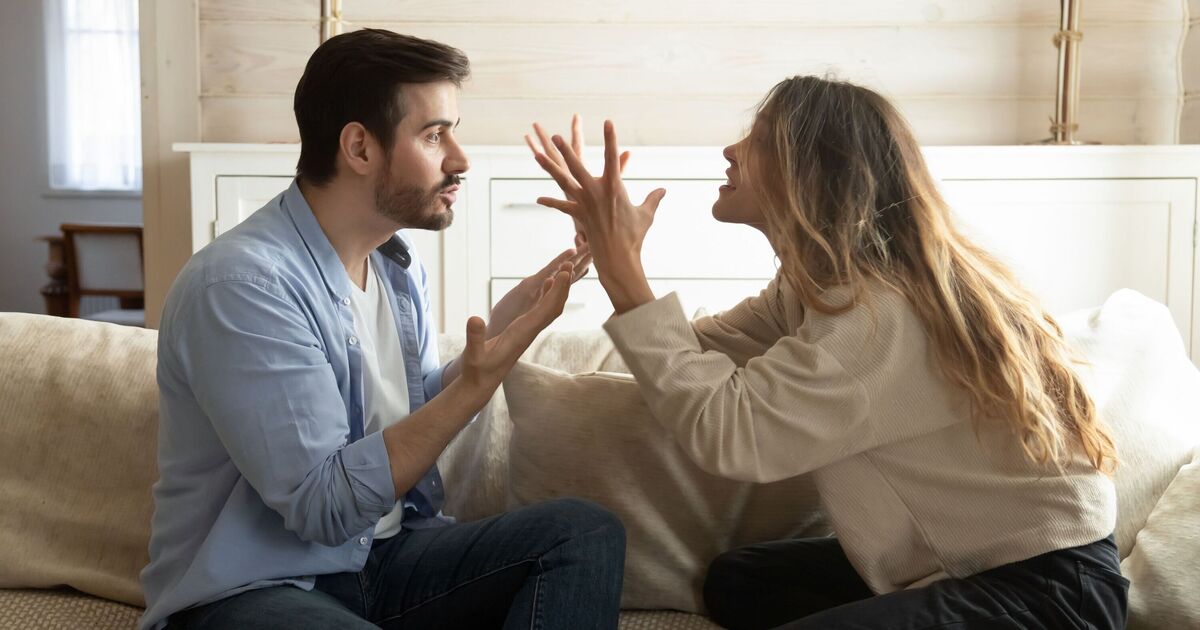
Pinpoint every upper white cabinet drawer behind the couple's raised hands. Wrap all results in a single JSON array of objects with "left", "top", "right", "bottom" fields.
[{"left": 491, "top": 179, "right": 775, "bottom": 278}]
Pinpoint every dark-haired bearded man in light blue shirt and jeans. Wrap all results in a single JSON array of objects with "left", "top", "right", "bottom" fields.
[{"left": 140, "top": 30, "right": 624, "bottom": 629}]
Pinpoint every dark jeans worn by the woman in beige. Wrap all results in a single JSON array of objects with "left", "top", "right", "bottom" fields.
[{"left": 704, "top": 536, "right": 1129, "bottom": 630}]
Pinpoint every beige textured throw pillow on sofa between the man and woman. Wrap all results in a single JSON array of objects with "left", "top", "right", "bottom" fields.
[{"left": 504, "top": 362, "right": 824, "bottom": 612}]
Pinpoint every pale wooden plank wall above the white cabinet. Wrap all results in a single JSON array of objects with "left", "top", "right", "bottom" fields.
[{"left": 199, "top": 0, "right": 1200, "bottom": 145}]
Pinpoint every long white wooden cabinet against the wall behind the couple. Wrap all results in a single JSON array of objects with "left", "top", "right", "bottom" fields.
[{"left": 176, "top": 139, "right": 1200, "bottom": 362}]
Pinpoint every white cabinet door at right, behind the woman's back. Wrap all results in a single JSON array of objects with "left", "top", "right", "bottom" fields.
[{"left": 942, "top": 179, "right": 1196, "bottom": 329}]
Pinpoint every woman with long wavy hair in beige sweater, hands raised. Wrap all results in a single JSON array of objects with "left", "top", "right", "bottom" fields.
[{"left": 523, "top": 77, "right": 1128, "bottom": 629}]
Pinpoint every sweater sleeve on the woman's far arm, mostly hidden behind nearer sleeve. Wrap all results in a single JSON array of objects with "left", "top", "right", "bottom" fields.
[{"left": 691, "top": 276, "right": 786, "bottom": 367}]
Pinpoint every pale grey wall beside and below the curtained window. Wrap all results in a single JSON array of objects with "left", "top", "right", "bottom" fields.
[{"left": 0, "top": 0, "right": 142, "bottom": 313}]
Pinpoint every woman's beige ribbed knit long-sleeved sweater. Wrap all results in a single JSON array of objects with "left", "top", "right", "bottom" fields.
[{"left": 605, "top": 277, "right": 1116, "bottom": 593}]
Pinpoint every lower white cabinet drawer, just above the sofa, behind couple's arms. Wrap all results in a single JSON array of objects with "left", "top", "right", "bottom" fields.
[{"left": 491, "top": 278, "right": 769, "bottom": 330}]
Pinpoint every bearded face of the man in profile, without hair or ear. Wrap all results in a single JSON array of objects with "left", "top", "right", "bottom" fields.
[{"left": 374, "top": 82, "right": 470, "bottom": 230}]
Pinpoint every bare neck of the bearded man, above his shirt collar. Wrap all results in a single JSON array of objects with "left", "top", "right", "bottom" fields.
[{"left": 300, "top": 179, "right": 397, "bottom": 289}]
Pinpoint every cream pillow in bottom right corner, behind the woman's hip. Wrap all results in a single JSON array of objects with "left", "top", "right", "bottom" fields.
[{"left": 1121, "top": 450, "right": 1200, "bottom": 630}]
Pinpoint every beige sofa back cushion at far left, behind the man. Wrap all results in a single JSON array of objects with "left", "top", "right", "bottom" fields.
[{"left": 0, "top": 313, "right": 158, "bottom": 606}]
